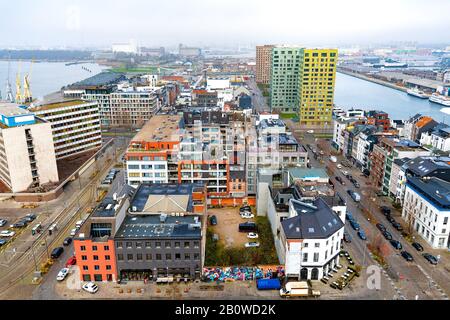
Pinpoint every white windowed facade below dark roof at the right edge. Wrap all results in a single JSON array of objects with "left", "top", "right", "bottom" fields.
[{"left": 402, "top": 184, "right": 450, "bottom": 249}]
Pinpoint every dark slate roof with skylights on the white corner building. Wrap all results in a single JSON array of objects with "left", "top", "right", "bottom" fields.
[{"left": 281, "top": 198, "right": 344, "bottom": 239}]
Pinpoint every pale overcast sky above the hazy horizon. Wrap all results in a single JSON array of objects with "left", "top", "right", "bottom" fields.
[{"left": 0, "top": 0, "right": 450, "bottom": 47}]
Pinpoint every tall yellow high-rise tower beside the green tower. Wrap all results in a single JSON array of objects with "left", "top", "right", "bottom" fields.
[{"left": 299, "top": 48, "right": 338, "bottom": 127}]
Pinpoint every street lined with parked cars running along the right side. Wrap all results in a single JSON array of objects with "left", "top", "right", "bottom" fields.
[{"left": 296, "top": 130, "right": 450, "bottom": 299}]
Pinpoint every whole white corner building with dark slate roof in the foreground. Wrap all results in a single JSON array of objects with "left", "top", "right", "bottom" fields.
[{"left": 278, "top": 198, "right": 344, "bottom": 280}]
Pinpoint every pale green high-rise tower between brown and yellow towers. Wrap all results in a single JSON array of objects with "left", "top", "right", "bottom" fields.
[{"left": 269, "top": 46, "right": 302, "bottom": 113}]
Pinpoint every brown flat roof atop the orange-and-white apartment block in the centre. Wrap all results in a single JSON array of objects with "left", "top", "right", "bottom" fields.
[{"left": 131, "top": 114, "right": 181, "bottom": 141}]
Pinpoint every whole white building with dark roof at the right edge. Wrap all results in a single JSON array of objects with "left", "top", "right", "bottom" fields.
[{"left": 402, "top": 177, "right": 450, "bottom": 249}]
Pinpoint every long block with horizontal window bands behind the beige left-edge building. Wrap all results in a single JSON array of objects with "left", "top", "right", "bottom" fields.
[{"left": 28, "top": 100, "right": 102, "bottom": 160}]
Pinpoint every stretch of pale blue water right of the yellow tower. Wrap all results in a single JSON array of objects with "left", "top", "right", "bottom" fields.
[{"left": 334, "top": 73, "right": 450, "bottom": 124}]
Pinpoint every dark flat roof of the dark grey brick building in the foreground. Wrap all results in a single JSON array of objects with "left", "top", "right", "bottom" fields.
[{"left": 114, "top": 214, "right": 201, "bottom": 239}]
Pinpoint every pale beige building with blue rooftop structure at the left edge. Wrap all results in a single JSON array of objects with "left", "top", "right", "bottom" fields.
[{"left": 0, "top": 103, "right": 59, "bottom": 192}]
